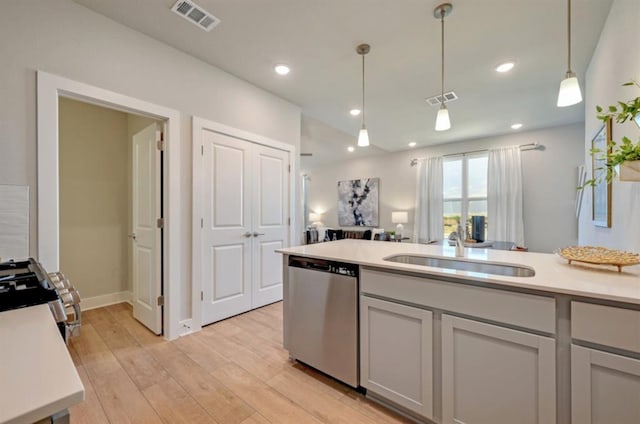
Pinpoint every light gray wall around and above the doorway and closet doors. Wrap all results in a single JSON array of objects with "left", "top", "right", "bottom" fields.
[{"left": 0, "top": 0, "right": 300, "bottom": 320}]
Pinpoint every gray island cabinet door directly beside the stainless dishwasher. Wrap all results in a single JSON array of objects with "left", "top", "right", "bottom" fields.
[{"left": 360, "top": 296, "right": 433, "bottom": 418}]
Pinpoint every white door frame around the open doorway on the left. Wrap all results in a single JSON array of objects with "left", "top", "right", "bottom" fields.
[{"left": 37, "top": 71, "right": 182, "bottom": 340}]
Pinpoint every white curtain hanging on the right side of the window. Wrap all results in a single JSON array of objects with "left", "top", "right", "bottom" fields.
[{"left": 487, "top": 146, "right": 524, "bottom": 246}]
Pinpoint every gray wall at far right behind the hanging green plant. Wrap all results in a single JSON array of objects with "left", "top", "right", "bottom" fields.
[{"left": 580, "top": 0, "right": 640, "bottom": 252}]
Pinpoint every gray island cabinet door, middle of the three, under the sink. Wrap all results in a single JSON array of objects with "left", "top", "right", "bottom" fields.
[{"left": 442, "top": 315, "right": 556, "bottom": 424}]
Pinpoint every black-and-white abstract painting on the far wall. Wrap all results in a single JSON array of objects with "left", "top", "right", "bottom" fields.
[{"left": 338, "top": 178, "right": 378, "bottom": 227}]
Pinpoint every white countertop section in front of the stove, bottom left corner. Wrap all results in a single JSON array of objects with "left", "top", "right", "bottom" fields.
[{"left": 0, "top": 305, "right": 84, "bottom": 424}]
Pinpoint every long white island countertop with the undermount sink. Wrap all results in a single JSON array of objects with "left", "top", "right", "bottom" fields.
[{"left": 277, "top": 239, "right": 640, "bottom": 305}]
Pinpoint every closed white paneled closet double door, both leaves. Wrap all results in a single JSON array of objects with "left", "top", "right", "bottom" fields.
[{"left": 201, "top": 130, "right": 289, "bottom": 324}]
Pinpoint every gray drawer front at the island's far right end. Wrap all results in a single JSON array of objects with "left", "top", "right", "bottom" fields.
[{"left": 571, "top": 302, "right": 640, "bottom": 353}]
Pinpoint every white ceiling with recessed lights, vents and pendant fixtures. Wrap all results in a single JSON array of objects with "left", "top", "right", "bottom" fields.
[{"left": 74, "top": 0, "right": 611, "bottom": 161}]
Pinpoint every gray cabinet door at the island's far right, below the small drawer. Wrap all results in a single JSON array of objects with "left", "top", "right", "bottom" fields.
[{"left": 571, "top": 345, "right": 640, "bottom": 424}]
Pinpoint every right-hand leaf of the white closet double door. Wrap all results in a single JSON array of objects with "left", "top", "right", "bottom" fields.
[{"left": 251, "top": 145, "right": 289, "bottom": 308}]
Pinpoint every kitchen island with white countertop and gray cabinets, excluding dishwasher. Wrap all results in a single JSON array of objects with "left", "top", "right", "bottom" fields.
[{"left": 280, "top": 240, "right": 640, "bottom": 424}]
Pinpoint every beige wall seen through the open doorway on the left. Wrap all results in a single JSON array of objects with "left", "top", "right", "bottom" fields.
[{"left": 59, "top": 99, "right": 131, "bottom": 298}]
